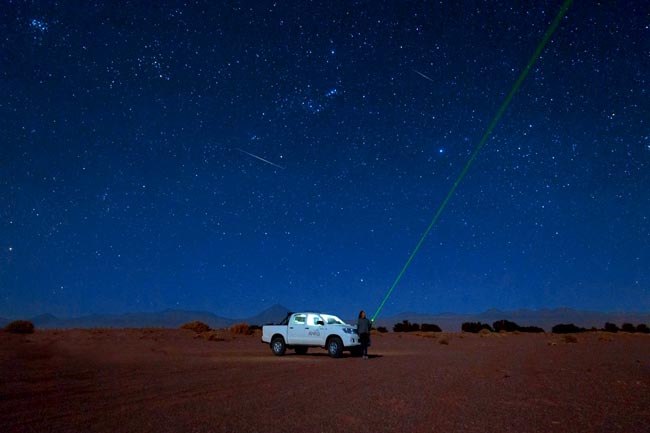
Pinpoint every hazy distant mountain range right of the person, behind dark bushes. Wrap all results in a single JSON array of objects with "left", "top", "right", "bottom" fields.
[{"left": 377, "top": 308, "right": 650, "bottom": 332}]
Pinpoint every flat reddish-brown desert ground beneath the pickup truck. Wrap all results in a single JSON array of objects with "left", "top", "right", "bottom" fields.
[{"left": 0, "top": 329, "right": 650, "bottom": 433}]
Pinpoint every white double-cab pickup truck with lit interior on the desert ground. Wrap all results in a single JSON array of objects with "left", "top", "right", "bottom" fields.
[{"left": 262, "top": 312, "right": 361, "bottom": 358}]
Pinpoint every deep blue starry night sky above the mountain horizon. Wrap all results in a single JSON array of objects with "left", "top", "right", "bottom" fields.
[{"left": 0, "top": 0, "right": 650, "bottom": 318}]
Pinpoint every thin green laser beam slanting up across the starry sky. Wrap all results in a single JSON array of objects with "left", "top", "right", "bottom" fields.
[{"left": 371, "top": 0, "right": 573, "bottom": 321}]
